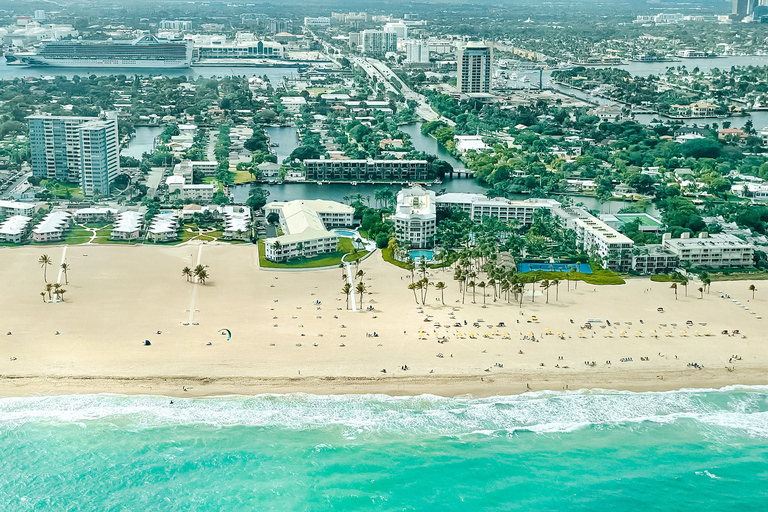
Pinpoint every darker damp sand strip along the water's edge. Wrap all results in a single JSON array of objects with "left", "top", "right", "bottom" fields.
[{"left": 0, "top": 368, "right": 768, "bottom": 398}]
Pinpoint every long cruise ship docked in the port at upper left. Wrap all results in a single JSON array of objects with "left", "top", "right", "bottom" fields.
[{"left": 6, "top": 34, "right": 193, "bottom": 69}]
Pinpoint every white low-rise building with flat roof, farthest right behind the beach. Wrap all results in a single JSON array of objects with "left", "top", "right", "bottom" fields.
[{"left": 661, "top": 232, "right": 755, "bottom": 268}]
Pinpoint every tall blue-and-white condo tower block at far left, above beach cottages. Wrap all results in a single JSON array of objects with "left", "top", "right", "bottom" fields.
[{"left": 27, "top": 112, "right": 120, "bottom": 195}]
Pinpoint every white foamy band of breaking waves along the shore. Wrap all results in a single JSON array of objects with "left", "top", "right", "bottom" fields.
[{"left": 0, "top": 386, "right": 768, "bottom": 438}]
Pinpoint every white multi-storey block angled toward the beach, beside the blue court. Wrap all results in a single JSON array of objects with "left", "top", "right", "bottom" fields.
[{"left": 552, "top": 206, "right": 635, "bottom": 272}]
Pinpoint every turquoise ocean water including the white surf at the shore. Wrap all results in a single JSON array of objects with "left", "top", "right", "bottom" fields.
[{"left": 0, "top": 387, "right": 768, "bottom": 512}]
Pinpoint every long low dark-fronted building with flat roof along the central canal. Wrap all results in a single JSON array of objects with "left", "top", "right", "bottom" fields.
[{"left": 303, "top": 159, "right": 429, "bottom": 183}]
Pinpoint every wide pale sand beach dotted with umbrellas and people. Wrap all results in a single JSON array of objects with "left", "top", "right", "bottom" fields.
[{"left": 0, "top": 244, "right": 768, "bottom": 396}]
